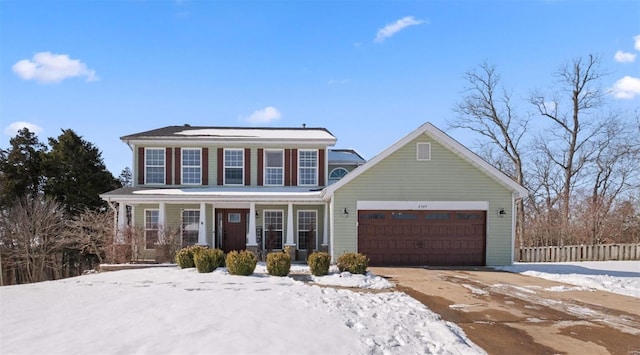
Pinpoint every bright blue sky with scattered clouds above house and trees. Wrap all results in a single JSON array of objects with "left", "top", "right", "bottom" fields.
[{"left": 0, "top": 0, "right": 640, "bottom": 176}]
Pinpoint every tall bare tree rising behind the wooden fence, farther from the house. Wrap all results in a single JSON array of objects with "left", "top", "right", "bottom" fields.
[{"left": 530, "top": 55, "right": 611, "bottom": 245}]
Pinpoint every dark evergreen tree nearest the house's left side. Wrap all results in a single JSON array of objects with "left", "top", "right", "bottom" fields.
[{"left": 44, "top": 129, "right": 121, "bottom": 215}]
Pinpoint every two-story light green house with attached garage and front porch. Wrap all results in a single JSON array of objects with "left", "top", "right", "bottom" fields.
[{"left": 101, "top": 123, "right": 527, "bottom": 265}]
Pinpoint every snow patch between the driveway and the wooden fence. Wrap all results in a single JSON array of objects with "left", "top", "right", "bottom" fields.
[{"left": 495, "top": 261, "right": 640, "bottom": 298}]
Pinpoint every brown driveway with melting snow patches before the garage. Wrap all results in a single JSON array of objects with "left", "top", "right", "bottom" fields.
[{"left": 370, "top": 267, "right": 640, "bottom": 355}]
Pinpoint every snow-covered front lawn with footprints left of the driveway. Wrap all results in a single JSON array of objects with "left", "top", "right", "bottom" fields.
[{"left": 0, "top": 264, "right": 483, "bottom": 355}]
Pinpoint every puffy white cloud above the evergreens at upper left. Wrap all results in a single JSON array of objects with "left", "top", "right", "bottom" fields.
[{"left": 12, "top": 52, "right": 98, "bottom": 83}]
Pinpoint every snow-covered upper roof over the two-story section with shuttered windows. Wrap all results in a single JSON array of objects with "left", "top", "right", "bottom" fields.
[{"left": 120, "top": 125, "right": 336, "bottom": 145}]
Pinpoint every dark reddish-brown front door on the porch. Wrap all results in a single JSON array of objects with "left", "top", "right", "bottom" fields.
[{"left": 216, "top": 209, "right": 249, "bottom": 253}]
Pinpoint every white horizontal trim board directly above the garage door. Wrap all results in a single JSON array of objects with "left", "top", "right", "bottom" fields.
[{"left": 356, "top": 201, "right": 489, "bottom": 211}]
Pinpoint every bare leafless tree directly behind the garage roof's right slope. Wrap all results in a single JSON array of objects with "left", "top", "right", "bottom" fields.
[{"left": 449, "top": 62, "right": 529, "bottom": 245}]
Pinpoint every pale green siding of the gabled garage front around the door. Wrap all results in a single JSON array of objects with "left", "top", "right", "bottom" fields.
[{"left": 333, "top": 135, "right": 513, "bottom": 265}]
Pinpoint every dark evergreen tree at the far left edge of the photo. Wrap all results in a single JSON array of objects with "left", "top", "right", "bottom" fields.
[{"left": 0, "top": 128, "right": 47, "bottom": 208}]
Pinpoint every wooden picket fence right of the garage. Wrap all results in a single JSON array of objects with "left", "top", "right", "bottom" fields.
[{"left": 518, "top": 244, "right": 640, "bottom": 262}]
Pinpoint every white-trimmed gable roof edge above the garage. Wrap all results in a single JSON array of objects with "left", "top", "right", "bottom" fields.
[{"left": 324, "top": 122, "right": 529, "bottom": 198}]
